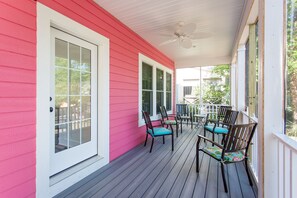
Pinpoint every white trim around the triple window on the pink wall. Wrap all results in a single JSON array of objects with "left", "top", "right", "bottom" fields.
[{"left": 138, "top": 53, "right": 174, "bottom": 127}]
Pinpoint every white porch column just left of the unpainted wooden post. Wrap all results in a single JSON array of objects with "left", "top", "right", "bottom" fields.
[{"left": 235, "top": 45, "right": 245, "bottom": 111}]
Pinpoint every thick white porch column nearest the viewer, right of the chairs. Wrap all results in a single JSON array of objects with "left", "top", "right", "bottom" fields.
[{"left": 258, "top": 0, "right": 285, "bottom": 198}]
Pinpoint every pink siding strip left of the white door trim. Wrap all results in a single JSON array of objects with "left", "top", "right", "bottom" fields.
[{"left": 0, "top": 0, "right": 36, "bottom": 197}]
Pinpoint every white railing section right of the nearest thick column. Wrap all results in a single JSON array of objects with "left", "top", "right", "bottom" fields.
[{"left": 274, "top": 133, "right": 297, "bottom": 198}]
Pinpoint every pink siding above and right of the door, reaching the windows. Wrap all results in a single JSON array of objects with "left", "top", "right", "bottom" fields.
[{"left": 39, "top": 0, "right": 174, "bottom": 160}]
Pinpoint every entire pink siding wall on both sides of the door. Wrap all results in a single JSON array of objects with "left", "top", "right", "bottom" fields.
[{"left": 0, "top": 0, "right": 174, "bottom": 197}]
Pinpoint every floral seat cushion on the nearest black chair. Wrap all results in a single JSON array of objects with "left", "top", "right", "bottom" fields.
[{"left": 203, "top": 146, "right": 245, "bottom": 162}]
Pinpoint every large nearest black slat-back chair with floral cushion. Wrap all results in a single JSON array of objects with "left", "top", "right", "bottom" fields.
[{"left": 196, "top": 123, "right": 257, "bottom": 192}]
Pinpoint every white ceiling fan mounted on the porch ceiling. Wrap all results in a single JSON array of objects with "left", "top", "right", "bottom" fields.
[{"left": 159, "top": 21, "right": 210, "bottom": 49}]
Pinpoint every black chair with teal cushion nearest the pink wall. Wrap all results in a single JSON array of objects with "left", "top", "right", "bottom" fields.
[{"left": 142, "top": 111, "right": 174, "bottom": 153}]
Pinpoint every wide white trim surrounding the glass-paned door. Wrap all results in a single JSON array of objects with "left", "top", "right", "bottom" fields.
[{"left": 36, "top": 2, "right": 109, "bottom": 197}]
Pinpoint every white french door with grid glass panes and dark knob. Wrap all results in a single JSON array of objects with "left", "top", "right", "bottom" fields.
[{"left": 49, "top": 28, "right": 98, "bottom": 175}]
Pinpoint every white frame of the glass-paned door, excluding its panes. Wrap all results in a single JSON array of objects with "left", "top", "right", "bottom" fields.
[{"left": 50, "top": 28, "right": 98, "bottom": 175}]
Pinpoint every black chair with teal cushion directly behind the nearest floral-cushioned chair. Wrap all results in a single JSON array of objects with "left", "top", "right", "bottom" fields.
[{"left": 204, "top": 110, "right": 238, "bottom": 144}]
